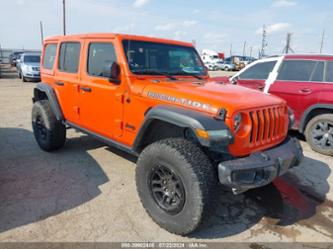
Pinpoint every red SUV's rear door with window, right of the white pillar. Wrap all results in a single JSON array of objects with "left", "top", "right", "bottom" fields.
[{"left": 269, "top": 60, "right": 325, "bottom": 127}]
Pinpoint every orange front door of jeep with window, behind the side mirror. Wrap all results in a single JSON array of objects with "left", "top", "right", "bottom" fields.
[{"left": 79, "top": 39, "right": 124, "bottom": 140}]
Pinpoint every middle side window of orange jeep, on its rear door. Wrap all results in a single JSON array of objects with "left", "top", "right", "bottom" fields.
[{"left": 59, "top": 42, "right": 81, "bottom": 73}]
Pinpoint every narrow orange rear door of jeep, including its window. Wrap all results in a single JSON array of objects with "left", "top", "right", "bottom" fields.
[{"left": 54, "top": 41, "right": 82, "bottom": 123}]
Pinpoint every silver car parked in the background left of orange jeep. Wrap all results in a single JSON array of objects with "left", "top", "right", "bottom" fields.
[{"left": 17, "top": 53, "right": 40, "bottom": 82}]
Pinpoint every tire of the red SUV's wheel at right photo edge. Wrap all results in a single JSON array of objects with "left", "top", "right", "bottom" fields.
[{"left": 304, "top": 114, "right": 333, "bottom": 156}]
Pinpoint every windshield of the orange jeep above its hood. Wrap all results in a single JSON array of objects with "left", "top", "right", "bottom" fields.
[{"left": 123, "top": 40, "right": 207, "bottom": 76}]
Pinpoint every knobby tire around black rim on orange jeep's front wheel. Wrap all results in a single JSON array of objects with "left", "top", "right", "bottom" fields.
[{"left": 136, "top": 138, "right": 217, "bottom": 235}]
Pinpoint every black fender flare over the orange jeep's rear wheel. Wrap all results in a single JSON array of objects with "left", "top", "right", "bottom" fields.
[{"left": 32, "top": 83, "right": 64, "bottom": 121}]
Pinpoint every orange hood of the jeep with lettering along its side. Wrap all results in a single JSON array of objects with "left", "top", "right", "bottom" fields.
[{"left": 142, "top": 81, "right": 285, "bottom": 117}]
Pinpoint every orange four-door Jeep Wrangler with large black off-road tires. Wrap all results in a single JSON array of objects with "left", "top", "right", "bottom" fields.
[{"left": 32, "top": 34, "right": 303, "bottom": 235}]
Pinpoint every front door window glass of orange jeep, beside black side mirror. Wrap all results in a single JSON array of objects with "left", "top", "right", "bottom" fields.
[{"left": 87, "top": 43, "right": 117, "bottom": 77}]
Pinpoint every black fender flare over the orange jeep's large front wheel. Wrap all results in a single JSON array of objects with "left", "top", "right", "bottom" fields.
[{"left": 133, "top": 105, "right": 234, "bottom": 152}]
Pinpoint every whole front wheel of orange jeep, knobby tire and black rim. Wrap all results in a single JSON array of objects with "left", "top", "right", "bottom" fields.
[{"left": 136, "top": 138, "right": 217, "bottom": 235}]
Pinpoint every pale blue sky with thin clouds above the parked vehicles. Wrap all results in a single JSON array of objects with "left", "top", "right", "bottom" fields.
[{"left": 0, "top": 0, "right": 333, "bottom": 56}]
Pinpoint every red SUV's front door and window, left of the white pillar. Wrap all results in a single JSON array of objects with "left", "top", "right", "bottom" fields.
[{"left": 237, "top": 60, "right": 277, "bottom": 91}]
